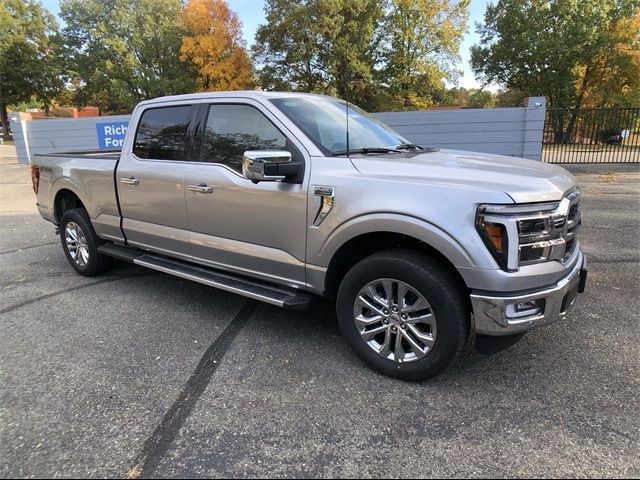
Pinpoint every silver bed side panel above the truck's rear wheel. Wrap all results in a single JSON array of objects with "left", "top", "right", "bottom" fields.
[{"left": 33, "top": 151, "right": 123, "bottom": 241}]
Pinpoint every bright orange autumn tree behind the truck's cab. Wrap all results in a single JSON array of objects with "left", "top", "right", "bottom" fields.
[{"left": 180, "top": 0, "right": 253, "bottom": 91}]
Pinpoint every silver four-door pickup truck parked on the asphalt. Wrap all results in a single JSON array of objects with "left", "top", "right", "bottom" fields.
[{"left": 32, "top": 92, "right": 586, "bottom": 380}]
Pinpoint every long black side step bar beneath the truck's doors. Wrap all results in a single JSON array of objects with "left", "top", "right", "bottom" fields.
[{"left": 98, "top": 243, "right": 313, "bottom": 310}]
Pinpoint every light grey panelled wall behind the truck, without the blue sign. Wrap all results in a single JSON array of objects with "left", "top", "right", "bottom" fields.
[{"left": 11, "top": 97, "right": 545, "bottom": 163}]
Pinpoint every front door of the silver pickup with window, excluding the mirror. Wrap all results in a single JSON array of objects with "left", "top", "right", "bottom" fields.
[{"left": 185, "top": 100, "right": 308, "bottom": 286}]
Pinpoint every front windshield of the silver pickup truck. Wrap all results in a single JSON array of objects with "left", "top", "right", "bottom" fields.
[{"left": 271, "top": 97, "right": 410, "bottom": 156}]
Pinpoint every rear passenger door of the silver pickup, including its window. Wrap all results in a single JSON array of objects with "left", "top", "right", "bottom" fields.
[{"left": 116, "top": 104, "right": 193, "bottom": 257}]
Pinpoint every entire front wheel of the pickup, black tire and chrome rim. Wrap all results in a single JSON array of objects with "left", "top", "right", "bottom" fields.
[{"left": 337, "top": 249, "right": 469, "bottom": 380}]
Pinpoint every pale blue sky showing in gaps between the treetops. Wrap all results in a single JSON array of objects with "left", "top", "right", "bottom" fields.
[{"left": 40, "top": 0, "right": 489, "bottom": 88}]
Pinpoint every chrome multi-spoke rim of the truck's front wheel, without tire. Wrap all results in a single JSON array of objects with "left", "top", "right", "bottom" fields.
[{"left": 353, "top": 278, "right": 437, "bottom": 363}]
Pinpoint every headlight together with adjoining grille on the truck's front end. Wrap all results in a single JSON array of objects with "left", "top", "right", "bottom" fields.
[{"left": 476, "top": 190, "right": 581, "bottom": 271}]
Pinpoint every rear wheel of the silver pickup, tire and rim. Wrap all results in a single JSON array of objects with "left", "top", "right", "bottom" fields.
[{"left": 60, "top": 208, "right": 113, "bottom": 277}]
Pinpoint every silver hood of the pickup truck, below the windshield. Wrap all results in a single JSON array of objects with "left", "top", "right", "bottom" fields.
[{"left": 351, "top": 150, "right": 577, "bottom": 203}]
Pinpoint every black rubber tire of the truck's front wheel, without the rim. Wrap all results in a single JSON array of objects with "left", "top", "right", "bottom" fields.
[{"left": 336, "top": 249, "right": 470, "bottom": 381}]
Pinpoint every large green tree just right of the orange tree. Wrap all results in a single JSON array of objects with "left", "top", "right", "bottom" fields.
[{"left": 253, "top": 0, "right": 384, "bottom": 108}]
